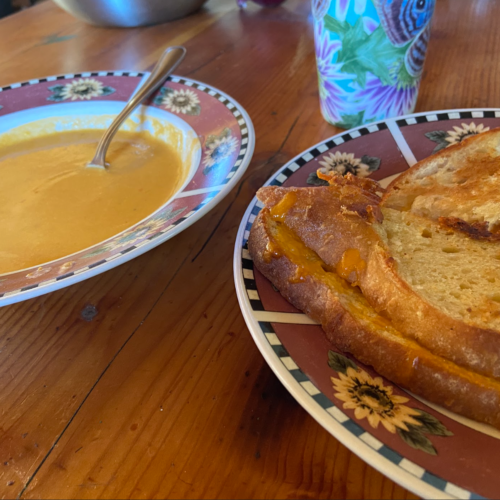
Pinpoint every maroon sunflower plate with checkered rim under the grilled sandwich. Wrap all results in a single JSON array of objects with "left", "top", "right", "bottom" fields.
[{"left": 234, "top": 109, "right": 500, "bottom": 498}]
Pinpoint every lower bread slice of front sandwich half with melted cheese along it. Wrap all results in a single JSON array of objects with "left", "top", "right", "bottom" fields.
[{"left": 248, "top": 211, "right": 500, "bottom": 428}]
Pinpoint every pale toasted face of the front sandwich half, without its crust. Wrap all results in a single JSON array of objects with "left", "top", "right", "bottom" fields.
[{"left": 373, "top": 208, "right": 500, "bottom": 332}]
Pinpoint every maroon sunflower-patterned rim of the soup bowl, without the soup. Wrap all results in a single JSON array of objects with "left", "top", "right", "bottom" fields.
[{"left": 0, "top": 71, "right": 255, "bottom": 305}]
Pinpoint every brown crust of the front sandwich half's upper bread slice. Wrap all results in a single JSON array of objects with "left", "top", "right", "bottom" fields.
[{"left": 257, "top": 187, "right": 500, "bottom": 379}]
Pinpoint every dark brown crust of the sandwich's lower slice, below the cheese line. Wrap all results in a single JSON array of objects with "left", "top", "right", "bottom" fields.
[{"left": 248, "top": 209, "right": 500, "bottom": 429}]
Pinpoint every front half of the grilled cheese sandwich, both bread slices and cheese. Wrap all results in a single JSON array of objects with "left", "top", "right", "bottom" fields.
[{"left": 248, "top": 176, "right": 500, "bottom": 428}]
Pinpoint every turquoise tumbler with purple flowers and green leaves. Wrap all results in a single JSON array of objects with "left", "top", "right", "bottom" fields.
[{"left": 312, "top": 0, "right": 435, "bottom": 128}]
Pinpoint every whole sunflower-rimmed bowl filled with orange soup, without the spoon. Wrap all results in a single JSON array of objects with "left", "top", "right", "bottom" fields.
[{"left": 0, "top": 72, "right": 254, "bottom": 305}]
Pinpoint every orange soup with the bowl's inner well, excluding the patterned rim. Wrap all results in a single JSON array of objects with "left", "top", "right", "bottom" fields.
[{"left": 0, "top": 103, "right": 201, "bottom": 275}]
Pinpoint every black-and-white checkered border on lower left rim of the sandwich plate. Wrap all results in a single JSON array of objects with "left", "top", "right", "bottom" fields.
[{"left": 241, "top": 234, "right": 484, "bottom": 500}]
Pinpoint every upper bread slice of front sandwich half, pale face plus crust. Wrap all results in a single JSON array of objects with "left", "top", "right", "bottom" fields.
[{"left": 257, "top": 186, "right": 500, "bottom": 378}]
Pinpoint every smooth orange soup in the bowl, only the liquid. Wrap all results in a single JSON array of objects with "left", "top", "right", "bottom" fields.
[{"left": 0, "top": 130, "right": 183, "bottom": 274}]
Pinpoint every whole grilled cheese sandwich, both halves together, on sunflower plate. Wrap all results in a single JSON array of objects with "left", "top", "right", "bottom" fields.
[{"left": 249, "top": 133, "right": 500, "bottom": 428}]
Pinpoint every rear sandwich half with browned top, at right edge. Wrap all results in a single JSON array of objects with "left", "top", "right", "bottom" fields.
[{"left": 382, "top": 129, "right": 500, "bottom": 235}]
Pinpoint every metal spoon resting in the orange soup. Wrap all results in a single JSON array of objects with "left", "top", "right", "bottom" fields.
[{"left": 87, "top": 47, "right": 186, "bottom": 169}]
